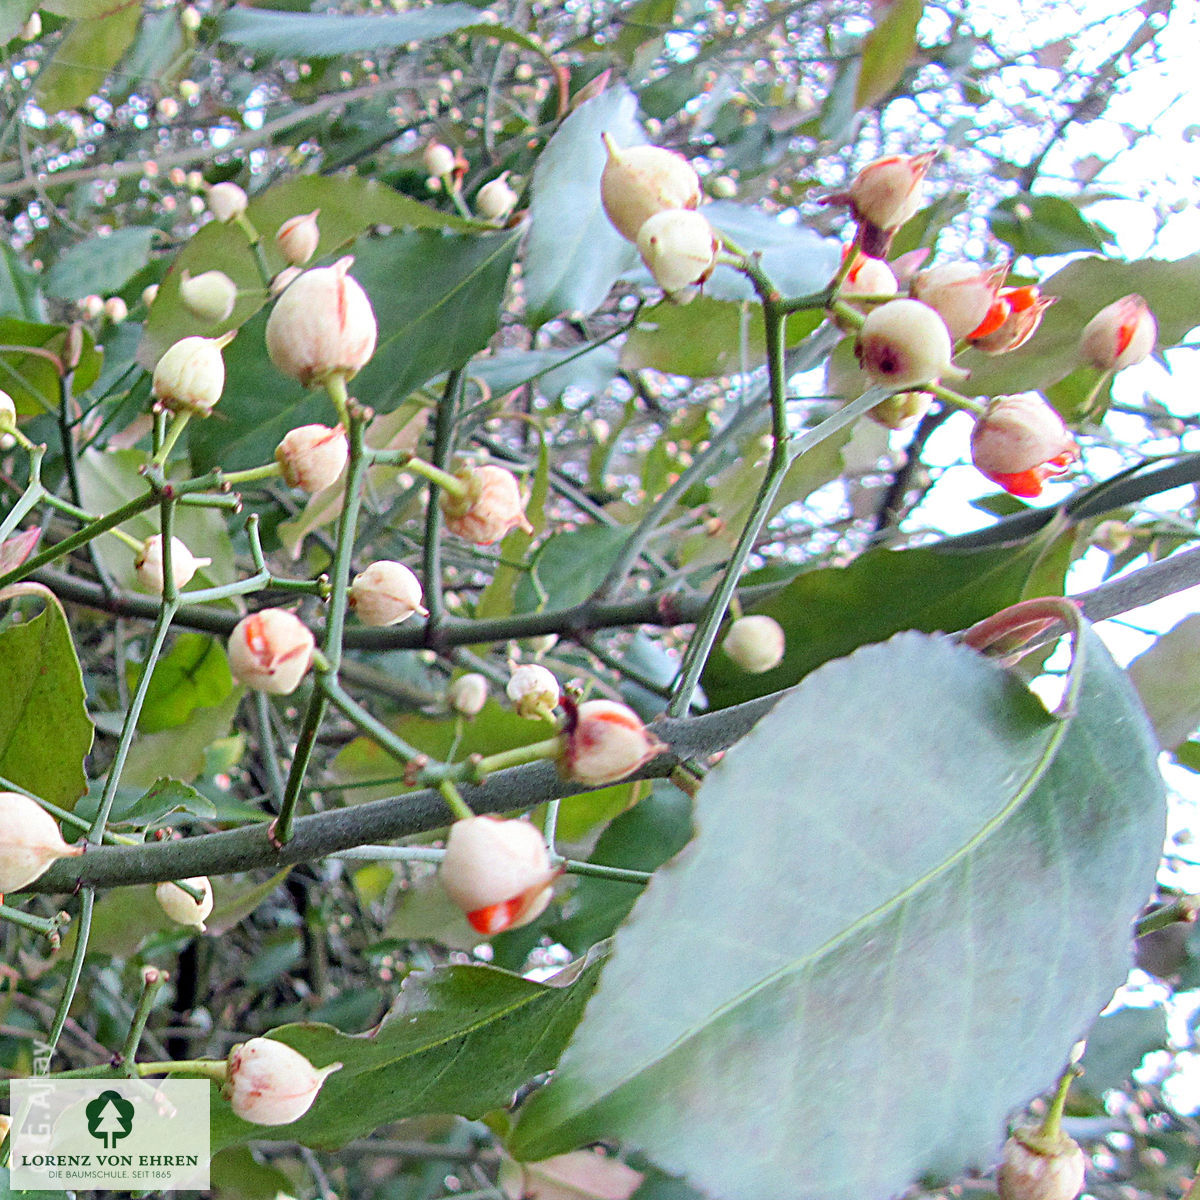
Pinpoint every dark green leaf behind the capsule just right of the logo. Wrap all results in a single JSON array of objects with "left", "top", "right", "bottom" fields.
[{"left": 212, "top": 940, "right": 609, "bottom": 1150}]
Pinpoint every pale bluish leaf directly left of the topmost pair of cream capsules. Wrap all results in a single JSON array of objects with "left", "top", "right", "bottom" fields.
[{"left": 524, "top": 84, "right": 646, "bottom": 328}]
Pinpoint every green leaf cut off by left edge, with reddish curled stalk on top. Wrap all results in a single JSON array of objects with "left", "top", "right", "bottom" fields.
[{"left": 0, "top": 584, "right": 92, "bottom": 808}]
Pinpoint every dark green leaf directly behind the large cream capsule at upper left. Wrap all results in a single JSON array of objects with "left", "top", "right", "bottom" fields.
[{"left": 188, "top": 229, "right": 520, "bottom": 470}]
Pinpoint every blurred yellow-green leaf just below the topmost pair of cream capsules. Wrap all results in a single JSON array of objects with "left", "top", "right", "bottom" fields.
[{"left": 620, "top": 296, "right": 823, "bottom": 379}]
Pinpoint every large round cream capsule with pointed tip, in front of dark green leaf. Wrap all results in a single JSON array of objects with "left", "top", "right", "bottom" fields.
[{"left": 266, "top": 257, "right": 377, "bottom": 388}]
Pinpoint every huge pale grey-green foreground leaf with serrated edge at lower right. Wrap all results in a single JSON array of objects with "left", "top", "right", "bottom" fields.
[{"left": 509, "top": 629, "right": 1165, "bottom": 1200}]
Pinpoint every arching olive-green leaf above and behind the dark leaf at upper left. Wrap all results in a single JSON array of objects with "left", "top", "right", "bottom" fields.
[{"left": 138, "top": 175, "right": 482, "bottom": 369}]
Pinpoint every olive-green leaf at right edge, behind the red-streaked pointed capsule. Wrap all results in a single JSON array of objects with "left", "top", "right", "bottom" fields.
[{"left": 956, "top": 254, "right": 1200, "bottom": 396}]
